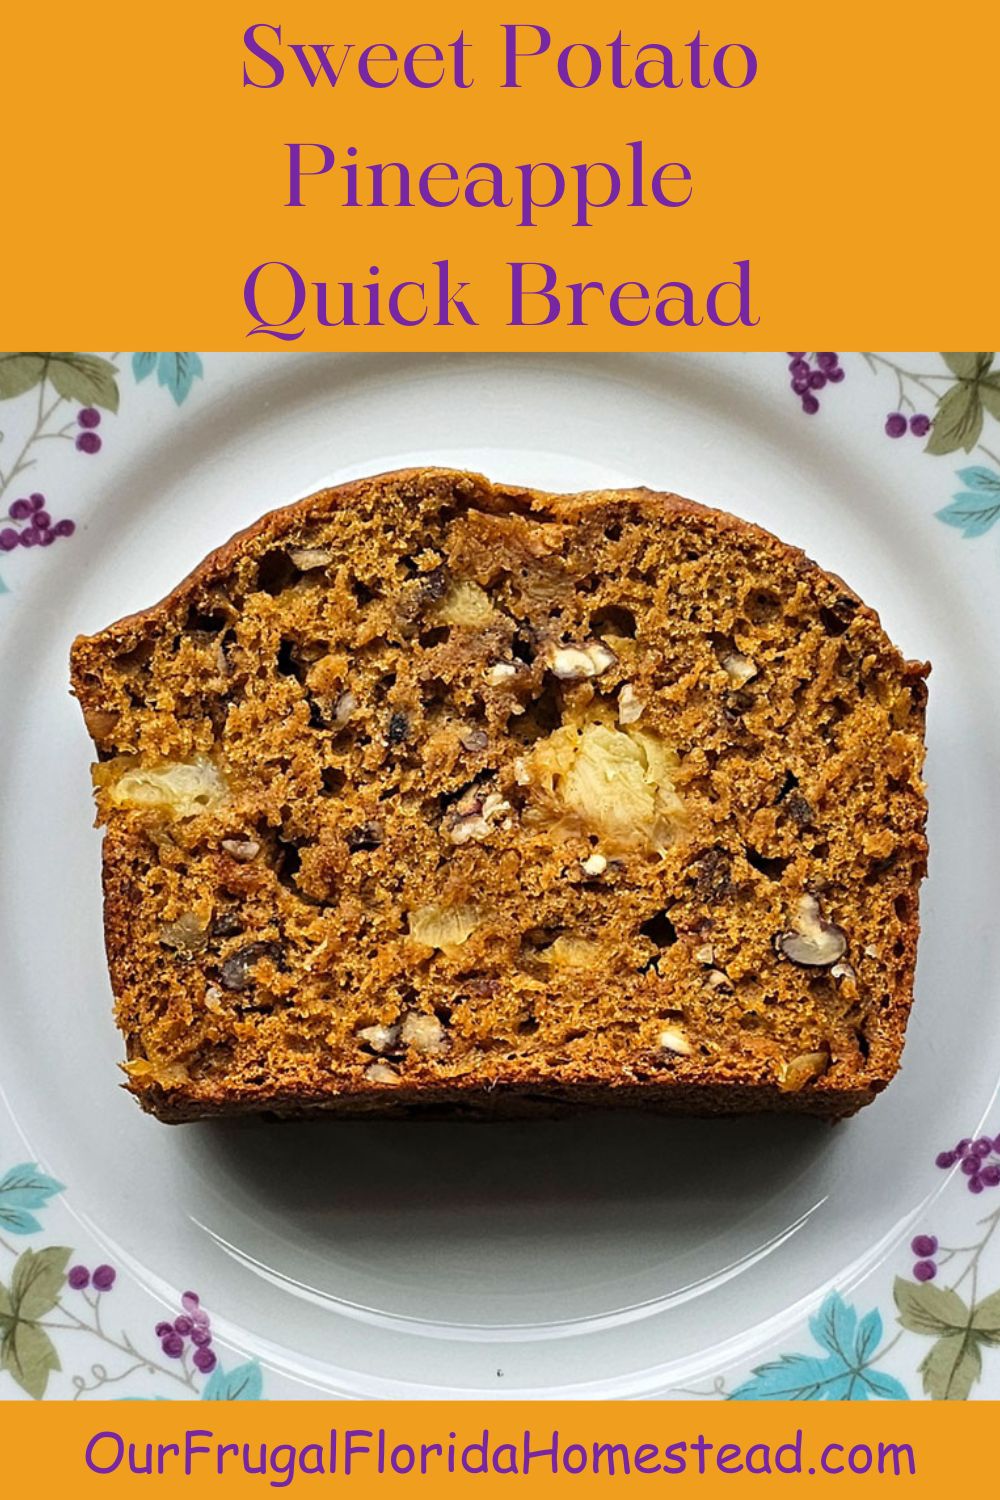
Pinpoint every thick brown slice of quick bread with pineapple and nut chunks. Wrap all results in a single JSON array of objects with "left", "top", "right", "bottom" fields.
[{"left": 72, "top": 470, "right": 928, "bottom": 1121}]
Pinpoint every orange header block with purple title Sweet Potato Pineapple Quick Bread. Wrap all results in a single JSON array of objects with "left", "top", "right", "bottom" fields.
[{"left": 7, "top": 0, "right": 1000, "bottom": 350}]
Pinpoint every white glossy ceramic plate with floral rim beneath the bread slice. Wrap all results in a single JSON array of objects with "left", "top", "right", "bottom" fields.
[{"left": 0, "top": 345, "right": 1000, "bottom": 1400}]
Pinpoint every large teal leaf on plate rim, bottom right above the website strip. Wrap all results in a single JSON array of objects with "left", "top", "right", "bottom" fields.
[{"left": 729, "top": 1292, "right": 907, "bottom": 1401}]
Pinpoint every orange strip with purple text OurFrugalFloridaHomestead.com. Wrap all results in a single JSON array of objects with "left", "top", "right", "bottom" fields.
[{"left": 0, "top": 1401, "right": 996, "bottom": 1500}]
